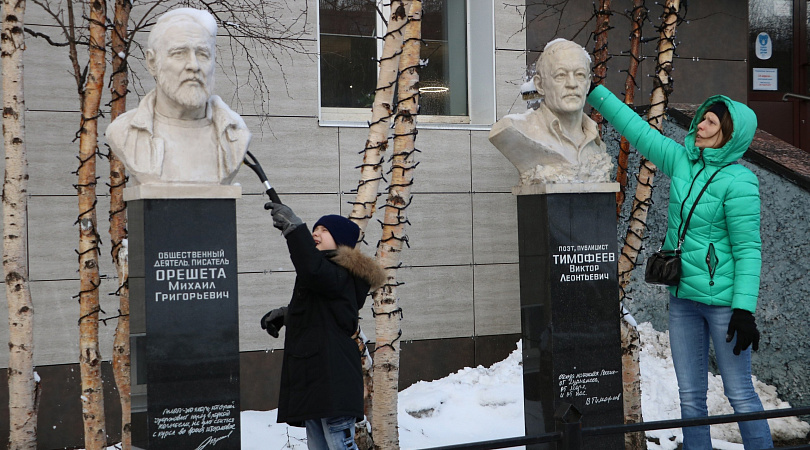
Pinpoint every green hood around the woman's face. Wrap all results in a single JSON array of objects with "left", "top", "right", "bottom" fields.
[{"left": 684, "top": 95, "right": 757, "bottom": 165}]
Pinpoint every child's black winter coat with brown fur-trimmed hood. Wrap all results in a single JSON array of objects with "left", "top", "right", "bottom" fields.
[{"left": 278, "top": 225, "right": 385, "bottom": 426}]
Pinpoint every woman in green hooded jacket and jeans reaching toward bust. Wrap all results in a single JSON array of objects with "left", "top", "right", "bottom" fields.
[{"left": 588, "top": 86, "right": 773, "bottom": 450}]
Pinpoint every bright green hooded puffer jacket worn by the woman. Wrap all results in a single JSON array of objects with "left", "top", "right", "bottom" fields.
[{"left": 588, "top": 86, "right": 762, "bottom": 312}]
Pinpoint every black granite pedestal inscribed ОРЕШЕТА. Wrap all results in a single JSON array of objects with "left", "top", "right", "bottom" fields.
[{"left": 127, "top": 199, "right": 241, "bottom": 450}]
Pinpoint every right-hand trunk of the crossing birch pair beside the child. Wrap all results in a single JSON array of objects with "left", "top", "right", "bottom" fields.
[{"left": 372, "top": 0, "right": 422, "bottom": 450}]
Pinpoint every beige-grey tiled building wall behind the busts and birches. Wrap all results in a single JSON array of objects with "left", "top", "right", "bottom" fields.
[{"left": 0, "top": 0, "right": 525, "bottom": 366}]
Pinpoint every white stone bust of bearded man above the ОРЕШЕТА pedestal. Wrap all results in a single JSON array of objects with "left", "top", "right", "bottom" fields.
[{"left": 105, "top": 8, "right": 250, "bottom": 185}]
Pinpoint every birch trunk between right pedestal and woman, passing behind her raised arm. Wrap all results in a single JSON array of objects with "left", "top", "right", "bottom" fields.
[{"left": 619, "top": 0, "right": 681, "bottom": 448}]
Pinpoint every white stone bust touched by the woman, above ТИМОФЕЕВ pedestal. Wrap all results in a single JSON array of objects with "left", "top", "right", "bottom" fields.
[{"left": 489, "top": 39, "right": 613, "bottom": 185}]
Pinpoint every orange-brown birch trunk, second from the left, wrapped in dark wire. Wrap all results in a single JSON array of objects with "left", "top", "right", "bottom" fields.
[{"left": 76, "top": 1, "right": 107, "bottom": 450}]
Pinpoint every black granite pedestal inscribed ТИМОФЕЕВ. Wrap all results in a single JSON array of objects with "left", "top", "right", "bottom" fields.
[{"left": 517, "top": 192, "right": 624, "bottom": 450}]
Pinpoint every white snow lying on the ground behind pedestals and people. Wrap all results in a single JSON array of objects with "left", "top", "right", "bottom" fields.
[{"left": 99, "top": 323, "right": 810, "bottom": 450}]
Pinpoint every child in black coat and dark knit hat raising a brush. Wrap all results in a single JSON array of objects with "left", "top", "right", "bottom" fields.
[{"left": 261, "top": 203, "right": 385, "bottom": 450}]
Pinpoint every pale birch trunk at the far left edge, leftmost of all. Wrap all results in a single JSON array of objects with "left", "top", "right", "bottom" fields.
[{"left": 0, "top": 0, "right": 39, "bottom": 449}]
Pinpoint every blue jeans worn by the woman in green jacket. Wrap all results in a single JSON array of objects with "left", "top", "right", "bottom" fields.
[{"left": 669, "top": 294, "right": 773, "bottom": 450}]
